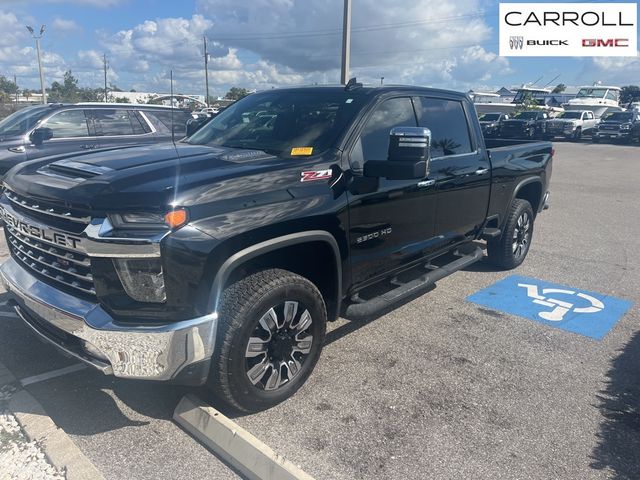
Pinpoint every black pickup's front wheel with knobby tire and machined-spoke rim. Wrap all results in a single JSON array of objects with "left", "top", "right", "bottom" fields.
[{"left": 207, "top": 269, "right": 327, "bottom": 412}]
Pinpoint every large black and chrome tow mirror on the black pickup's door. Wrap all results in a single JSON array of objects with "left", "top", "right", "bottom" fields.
[{"left": 364, "top": 127, "right": 431, "bottom": 180}]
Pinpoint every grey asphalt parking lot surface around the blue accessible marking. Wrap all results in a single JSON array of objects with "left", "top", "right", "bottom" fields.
[{"left": 0, "top": 142, "right": 640, "bottom": 479}]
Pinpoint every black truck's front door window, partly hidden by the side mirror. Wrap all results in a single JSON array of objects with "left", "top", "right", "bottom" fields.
[{"left": 351, "top": 97, "right": 417, "bottom": 171}]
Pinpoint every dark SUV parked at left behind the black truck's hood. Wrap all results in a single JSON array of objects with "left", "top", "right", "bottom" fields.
[{"left": 0, "top": 103, "right": 191, "bottom": 178}]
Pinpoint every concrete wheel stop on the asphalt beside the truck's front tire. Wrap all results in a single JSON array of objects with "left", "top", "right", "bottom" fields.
[{"left": 173, "top": 395, "right": 313, "bottom": 480}]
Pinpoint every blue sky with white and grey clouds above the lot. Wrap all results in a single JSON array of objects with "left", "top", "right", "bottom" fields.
[{"left": 0, "top": 0, "right": 640, "bottom": 96}]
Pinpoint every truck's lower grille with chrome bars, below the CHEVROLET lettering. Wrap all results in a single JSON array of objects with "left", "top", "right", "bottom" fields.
[{"left": 5, "top": 225, "right": 96, "bottom": 296}]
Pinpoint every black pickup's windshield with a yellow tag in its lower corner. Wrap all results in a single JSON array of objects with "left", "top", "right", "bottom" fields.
[{"left": 185, "top": 89, "right": 365, "bottom": 156}]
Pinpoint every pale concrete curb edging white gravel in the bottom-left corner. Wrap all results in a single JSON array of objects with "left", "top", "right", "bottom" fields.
[{"left": 0, "top": 363, "right": 104, "bottom": 480}]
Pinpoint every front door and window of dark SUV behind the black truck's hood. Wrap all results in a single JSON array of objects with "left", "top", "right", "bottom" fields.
[{"left": 26, "top": 108, "right": 95, "bottom": 160}]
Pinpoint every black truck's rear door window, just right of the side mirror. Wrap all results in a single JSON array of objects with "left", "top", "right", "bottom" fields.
[{"left": 418, "top": 97, "right": 472, "bottom": 157}]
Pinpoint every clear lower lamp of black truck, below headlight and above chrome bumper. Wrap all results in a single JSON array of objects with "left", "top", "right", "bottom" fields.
[{"left": 113, "top": 258, "right": 167, "bottom": 303}]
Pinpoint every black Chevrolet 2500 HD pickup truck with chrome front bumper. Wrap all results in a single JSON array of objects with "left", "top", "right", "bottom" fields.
[{"left": 0, "top": 82, "right": 553, "bottom": 411}]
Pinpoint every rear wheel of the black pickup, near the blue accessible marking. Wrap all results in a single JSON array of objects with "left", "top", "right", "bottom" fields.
[{"left": 487, "top": 198, "right": 534, "bottom": 269}]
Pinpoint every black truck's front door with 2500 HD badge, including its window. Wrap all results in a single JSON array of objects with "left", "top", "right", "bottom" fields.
[{"left": 349, "top": 97, "right": 435, "bottom": 285}]
